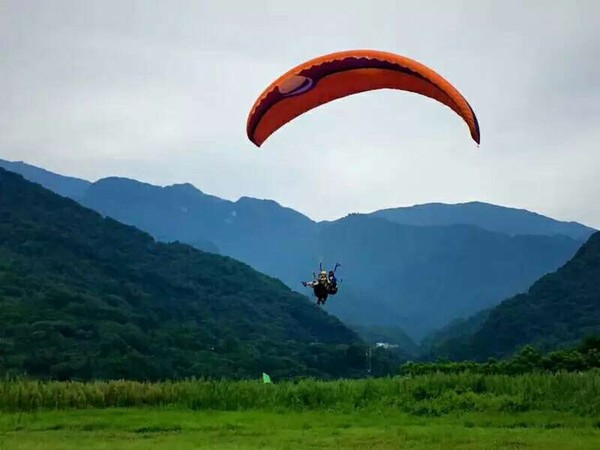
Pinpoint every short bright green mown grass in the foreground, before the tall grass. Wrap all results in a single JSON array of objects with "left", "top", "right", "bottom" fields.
[{"left": 0, "top": 408, "right": 600, "bottom": 450}]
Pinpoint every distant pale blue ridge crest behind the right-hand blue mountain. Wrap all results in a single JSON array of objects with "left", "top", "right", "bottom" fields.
[{"left": 370, "top": 202, "right": 596, "bottom": 241}]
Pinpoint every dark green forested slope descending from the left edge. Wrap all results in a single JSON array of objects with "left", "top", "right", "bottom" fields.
[{"left": 0, "top": 169, "right": 364, "bottom": 379}]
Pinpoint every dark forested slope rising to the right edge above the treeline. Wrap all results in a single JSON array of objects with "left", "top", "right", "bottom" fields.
[{"left": 440, "top": 232, "right": 600, "bottom": 359}]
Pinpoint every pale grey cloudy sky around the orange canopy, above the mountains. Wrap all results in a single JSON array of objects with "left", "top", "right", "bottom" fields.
[{"left": 0, "top": 0, "right": 600, "bottom": 228}]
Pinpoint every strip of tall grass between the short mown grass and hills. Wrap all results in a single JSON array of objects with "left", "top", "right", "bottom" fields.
[{"left": 0, "top": 371, "right": 600, "bottom": 416}]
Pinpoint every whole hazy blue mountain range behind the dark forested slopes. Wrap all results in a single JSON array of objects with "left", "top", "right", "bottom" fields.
[{"left": 0, "top": 157, "right": 595, "bottom": 340}]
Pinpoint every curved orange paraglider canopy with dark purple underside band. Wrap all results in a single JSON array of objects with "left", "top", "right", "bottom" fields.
[{"left": 246, "top": 50, "right": 480, "bottom": 147}]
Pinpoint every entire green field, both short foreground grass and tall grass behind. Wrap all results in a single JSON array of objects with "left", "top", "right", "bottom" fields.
[{"left": 0, "top": 371, "right": 600, "bottom": 450}]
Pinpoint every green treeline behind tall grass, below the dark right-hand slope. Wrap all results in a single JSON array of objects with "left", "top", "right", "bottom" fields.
[{"left": 399, "top": 336, "right": 600, "bottom": 376}]
